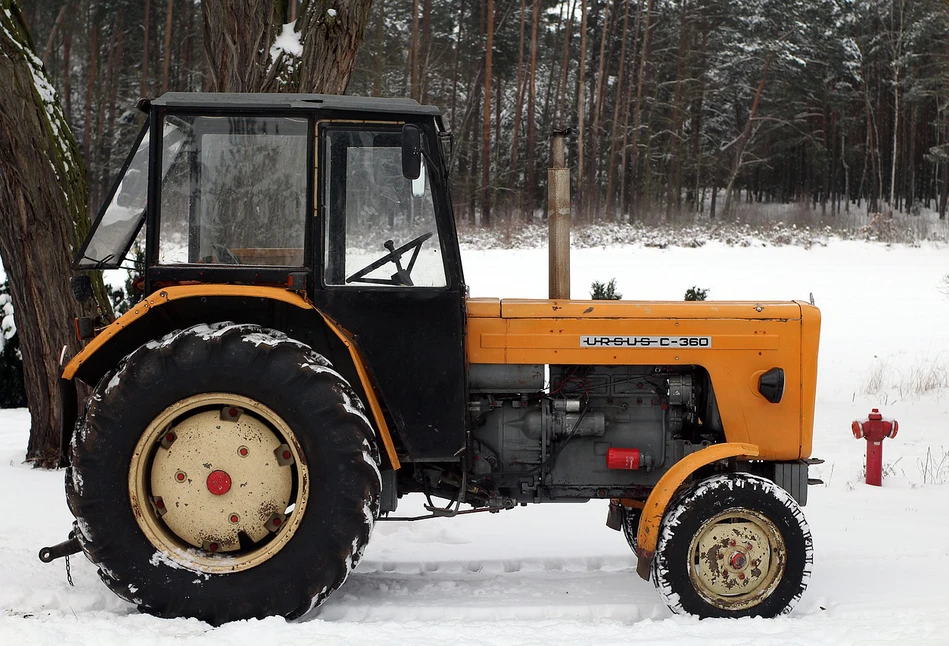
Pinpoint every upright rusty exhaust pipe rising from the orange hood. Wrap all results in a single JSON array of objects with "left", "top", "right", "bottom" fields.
[{"left": 547, "top": 128, "right": 570, "bottom": 300}]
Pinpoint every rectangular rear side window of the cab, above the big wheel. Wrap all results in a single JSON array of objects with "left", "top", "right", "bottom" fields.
[{"left": 158, "top": 115, "right": 308, "bottom": 266}]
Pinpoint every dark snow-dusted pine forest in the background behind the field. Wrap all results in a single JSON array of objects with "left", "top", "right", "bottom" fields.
[{"left": 16, "top": 0, "right": 949, "bottom": 227}]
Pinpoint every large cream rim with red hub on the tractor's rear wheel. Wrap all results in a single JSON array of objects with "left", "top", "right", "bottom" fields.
[{"left": 129, "top": 393, "right": 309, "bottom": 573}]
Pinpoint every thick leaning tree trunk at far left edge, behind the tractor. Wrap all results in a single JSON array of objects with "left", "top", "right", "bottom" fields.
[{"left": 0, "top": 0, "right": 111, "bottom": 468}]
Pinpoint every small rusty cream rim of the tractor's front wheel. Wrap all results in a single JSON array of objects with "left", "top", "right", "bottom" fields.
[{"left": 689, "top": 509, "right": 787, "bottom": 611}]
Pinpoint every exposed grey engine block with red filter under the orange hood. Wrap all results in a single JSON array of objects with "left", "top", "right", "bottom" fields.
[{"left": 470, "top": 365, "right": 721, "bottom": 503}]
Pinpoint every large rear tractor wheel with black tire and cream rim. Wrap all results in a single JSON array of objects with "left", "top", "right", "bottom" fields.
[{"left": 66, "top": 323, "right": 381, "bottom": 624}]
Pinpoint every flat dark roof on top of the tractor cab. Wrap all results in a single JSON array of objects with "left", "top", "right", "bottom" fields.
[{"left": 151, "top": 92, "right": 441, "bottom": 117}]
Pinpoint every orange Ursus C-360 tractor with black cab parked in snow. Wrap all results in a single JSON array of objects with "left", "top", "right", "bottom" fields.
[{"left": 40, "top": 93, "right": 820, "bottom": 624}]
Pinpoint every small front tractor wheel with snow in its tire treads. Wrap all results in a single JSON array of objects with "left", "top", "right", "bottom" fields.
[{"left": 652, "top": 473, "right": 813, "bottom": 617}]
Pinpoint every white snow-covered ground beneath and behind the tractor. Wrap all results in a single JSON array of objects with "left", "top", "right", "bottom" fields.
[{"left": 0, "top": 240, "right": 949, "bottom": 646}]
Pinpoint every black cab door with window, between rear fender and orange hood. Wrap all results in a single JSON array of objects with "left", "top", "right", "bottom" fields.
[{"left": 314, "top": 122, "right": 467, "bottom": 461}]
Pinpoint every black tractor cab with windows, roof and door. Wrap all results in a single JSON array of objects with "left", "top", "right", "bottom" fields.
[{"left": 74, "top": 93, "right": 466, "bottom": 459}]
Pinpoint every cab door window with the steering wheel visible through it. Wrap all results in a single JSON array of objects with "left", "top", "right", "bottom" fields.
[{"left": 322, "top": 127, "right": 447, "bottom": 288}]
